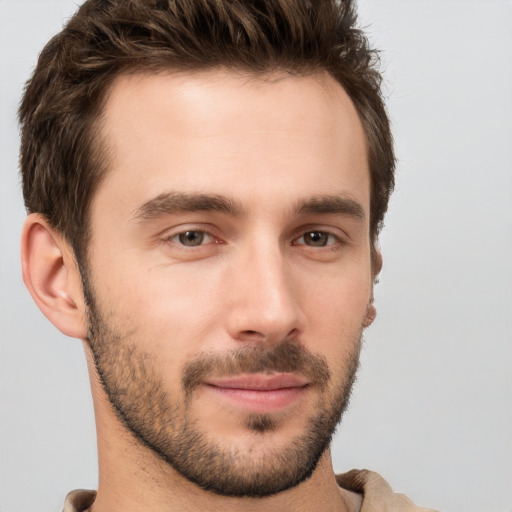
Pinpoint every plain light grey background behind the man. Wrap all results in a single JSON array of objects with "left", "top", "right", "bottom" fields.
[{"left": 0, "top": 0, "right": 512, "bottom": 512}]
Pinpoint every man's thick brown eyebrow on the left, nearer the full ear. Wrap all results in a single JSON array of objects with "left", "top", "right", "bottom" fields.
[{"left": 133, "top": 192, "right": 243, "bottom": 221}]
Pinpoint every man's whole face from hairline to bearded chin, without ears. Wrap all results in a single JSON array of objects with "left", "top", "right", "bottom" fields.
[{"left": 86, "top": 71, "right": 373, "bottom": 496}]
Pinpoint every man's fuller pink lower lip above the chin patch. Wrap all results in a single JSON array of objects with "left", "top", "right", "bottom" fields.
[{"left": 206, "top": 385, "right": 306, "bottom": 414}]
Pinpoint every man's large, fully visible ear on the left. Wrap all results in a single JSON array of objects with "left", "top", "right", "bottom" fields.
[{"left": 21, "top": 213, "right": 87, "bottom": 339}]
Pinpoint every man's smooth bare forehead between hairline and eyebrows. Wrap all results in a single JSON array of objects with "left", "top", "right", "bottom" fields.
[{"left": 93, "top": 70, "right": 369, "bottom": 220}]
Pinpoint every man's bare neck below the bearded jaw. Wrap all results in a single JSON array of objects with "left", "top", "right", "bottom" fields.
[{"left": 91, "top": 444, "right": 360, "bottom": 512}]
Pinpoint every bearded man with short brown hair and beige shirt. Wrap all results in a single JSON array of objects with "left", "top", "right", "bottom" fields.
[{"left": 20, "top": 0, "right": 436, "bottom": 512}]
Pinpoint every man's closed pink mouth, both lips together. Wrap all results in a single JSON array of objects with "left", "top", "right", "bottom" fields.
[{"left": 203, "top": 373, "right": 310, "bottom": 414}]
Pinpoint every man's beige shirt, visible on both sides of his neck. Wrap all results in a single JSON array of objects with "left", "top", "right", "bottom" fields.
[{"left": 62, "top": 469, "right": 436, "bottom": 512}]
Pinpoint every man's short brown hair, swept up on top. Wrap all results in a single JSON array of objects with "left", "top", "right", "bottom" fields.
[{"left": 19, "top": 0, "right": 395, "bottom": 257}]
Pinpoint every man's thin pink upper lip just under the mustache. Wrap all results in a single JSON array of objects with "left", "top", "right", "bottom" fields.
[{"left": 204, "top": 373, "right": 309, "bottom": 391}]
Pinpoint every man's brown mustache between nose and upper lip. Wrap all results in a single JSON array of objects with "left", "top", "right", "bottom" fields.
[{"left": 182, "top": 340, "right": 331, "bottom": 394}]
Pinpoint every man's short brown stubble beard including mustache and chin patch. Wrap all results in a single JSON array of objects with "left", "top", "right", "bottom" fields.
[{"left": 84, "top": 283, "right": 362, "bottom": 498}]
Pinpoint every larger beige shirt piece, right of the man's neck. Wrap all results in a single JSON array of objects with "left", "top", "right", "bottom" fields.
[{"left": 336, "top": 469, "right": 436, "bottom": 512}]
